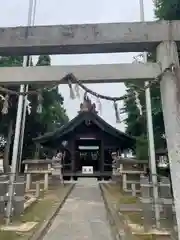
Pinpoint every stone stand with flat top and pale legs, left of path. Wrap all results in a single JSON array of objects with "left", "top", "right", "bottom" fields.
[{"left": 23, "top": 159, "right": 52, "bottom": 191}]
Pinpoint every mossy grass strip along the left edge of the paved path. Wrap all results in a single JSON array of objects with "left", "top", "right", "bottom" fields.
[{"left": 0, "top": 184, "right": 71, "bottom": 240}]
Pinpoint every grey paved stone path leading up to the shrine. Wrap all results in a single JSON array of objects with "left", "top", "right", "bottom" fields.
[{"left": 43, "top": 179, "right": 112, "bottom": 240}]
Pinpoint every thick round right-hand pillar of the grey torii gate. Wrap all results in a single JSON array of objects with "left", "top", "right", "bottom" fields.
[{"left": 157, "top": 41, "right": 180, "bottom": 239}]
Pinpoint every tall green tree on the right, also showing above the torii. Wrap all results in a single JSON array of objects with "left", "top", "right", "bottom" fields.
[{"left": 125, "top": 0, "right": 180, "bottom": 159}]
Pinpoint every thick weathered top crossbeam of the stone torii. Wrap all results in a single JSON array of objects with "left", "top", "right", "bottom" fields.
[{"left": 0, "top": 21, "right": 180, "bottom": 56}]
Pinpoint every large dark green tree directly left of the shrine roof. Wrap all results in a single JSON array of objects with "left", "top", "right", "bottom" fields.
[{"left": 23, "top": 55, "right": 69, "bottom": 158}]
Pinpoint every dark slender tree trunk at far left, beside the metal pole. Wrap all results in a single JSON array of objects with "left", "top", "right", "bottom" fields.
[{"left": 3, "top": 120, "right": 13, "bottom": 173}]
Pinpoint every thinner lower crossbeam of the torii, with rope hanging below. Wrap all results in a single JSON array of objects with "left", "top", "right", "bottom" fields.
[{"left": 0, "top": 63, "right": 161, "bottom": 85}]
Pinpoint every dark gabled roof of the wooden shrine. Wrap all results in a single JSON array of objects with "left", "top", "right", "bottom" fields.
[{"left": 33, "top": 112, "right": 135, "bottom": 146}]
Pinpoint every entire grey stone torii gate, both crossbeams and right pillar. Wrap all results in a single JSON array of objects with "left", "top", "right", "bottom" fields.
[{"left": 0, "top": 21, "right": 180, "bottom": 236}]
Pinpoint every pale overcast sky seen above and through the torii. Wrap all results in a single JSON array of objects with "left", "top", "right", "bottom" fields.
[{"left": 0, "top": 0, "right": 153, "bottom": 130}]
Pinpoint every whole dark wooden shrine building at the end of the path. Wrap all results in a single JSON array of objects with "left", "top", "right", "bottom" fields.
[{"left": 35, "top": 96, "right": 135, "bottom": 179}]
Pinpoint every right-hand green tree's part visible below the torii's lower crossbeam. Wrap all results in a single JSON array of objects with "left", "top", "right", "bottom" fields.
[{"left": 124, "top": 79, "right": 165, "bottom": 159}]
